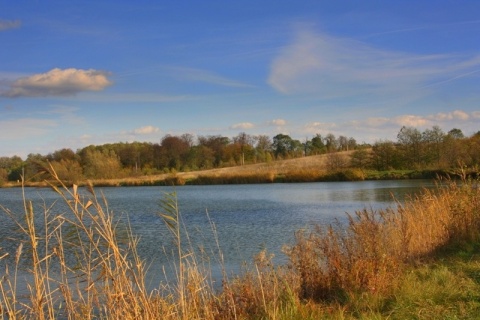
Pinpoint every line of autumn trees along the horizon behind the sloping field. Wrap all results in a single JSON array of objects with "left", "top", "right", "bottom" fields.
[{"left": 0, "top": 126, "right": 480, "bottom": 183}]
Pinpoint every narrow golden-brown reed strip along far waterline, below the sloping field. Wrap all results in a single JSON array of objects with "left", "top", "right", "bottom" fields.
[{"left": 0, "top": 166, "right": 460, "bottom": 188}]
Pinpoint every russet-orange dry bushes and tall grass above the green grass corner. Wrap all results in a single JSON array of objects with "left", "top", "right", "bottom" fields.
[{"left": 285, "top": 181, "right": 480, "bottom": 301}]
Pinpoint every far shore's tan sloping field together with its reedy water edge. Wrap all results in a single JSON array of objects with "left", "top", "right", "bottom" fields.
[{"left": 0, "top": 152, "right": 468, "bottom": 187}]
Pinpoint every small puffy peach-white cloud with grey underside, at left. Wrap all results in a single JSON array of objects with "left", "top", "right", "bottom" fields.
[{"left": 1, "top": 68, "right": 112, "bottom": 98}]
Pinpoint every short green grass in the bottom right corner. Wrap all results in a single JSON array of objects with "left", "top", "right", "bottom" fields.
[{"left": 312, "top": 248, "right": 480, "bottom": 319}]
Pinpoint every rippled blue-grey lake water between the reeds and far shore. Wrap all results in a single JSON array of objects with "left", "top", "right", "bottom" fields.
[{"left": 0, "top": 180, "right": 434, "bottom": 288}]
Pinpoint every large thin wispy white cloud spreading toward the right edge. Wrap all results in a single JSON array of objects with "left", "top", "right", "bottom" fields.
[{"left": 268, "top": 30, "right": 480, "bottom": 98}]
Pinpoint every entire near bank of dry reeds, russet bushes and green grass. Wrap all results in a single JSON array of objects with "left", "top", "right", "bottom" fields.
[{"left": 0, "top": 168, "right": 480, "bottom": 319}]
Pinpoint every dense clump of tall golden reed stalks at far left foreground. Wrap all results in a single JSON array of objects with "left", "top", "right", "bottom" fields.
[{"left": 0, "top": 166, "right": 178, "bottom": 319}]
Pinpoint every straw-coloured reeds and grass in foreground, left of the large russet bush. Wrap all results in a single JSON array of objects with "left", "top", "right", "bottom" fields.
[{"left": 0, "top": 166, "right": 288, "bottom": 319}]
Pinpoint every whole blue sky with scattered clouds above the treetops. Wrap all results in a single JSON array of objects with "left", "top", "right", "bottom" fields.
[{"left": 0, "top": 0, "right": 480, "bottom": 157}]
